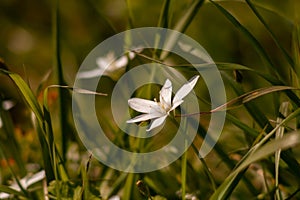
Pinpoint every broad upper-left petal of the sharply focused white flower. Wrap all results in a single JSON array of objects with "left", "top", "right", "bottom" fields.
[{"left": 128, "top": 98, "right": 161, "bottom": 113}]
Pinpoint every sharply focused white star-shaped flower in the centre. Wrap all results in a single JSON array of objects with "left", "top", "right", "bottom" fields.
[{"left": 127, "top": 76, "right": 199, "bottom": 131}]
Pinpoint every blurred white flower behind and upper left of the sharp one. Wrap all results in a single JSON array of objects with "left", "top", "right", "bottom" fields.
[{"left": 77, "top": 47, "right": 143, "bottom": 81}]
